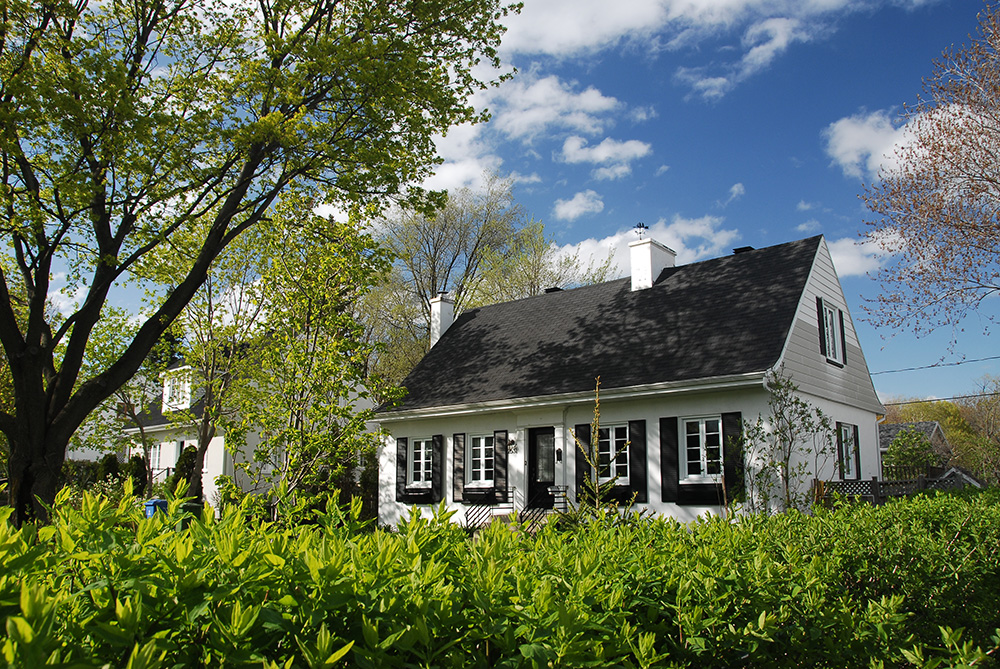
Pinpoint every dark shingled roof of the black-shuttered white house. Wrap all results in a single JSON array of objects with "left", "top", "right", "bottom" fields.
[{"left": 383, "top": 236, "right": 822, "bottom": 413}]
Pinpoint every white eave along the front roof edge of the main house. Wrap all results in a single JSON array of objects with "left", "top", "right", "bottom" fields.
[{"left": 375, "top": 371, "right": 766, "bottom": 423}]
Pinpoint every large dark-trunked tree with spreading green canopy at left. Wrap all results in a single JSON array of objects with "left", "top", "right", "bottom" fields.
[{"left": 0, "top": 0, "right": 507, "bottom": 522}]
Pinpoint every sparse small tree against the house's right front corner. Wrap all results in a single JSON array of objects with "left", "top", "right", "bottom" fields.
[{"left": 744, "top": 372, "right": 834, "bottom": 513}]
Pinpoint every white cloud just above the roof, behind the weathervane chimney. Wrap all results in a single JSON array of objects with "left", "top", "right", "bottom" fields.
[{"left": 559, "top": 215, "right": 740, "bottom": 276}]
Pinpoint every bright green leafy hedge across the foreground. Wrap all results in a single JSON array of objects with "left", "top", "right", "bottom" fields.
[{"left": 0, "top": 490, "right": 1000, "bottom": 669}]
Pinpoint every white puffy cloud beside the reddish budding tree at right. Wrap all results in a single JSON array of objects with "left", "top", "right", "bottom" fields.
[{"left": 823, "top": 110, "right": 906, "bottom": 179}]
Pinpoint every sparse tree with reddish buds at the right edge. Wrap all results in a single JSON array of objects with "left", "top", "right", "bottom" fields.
[{"left": 864, "top": 7, "right": 1000, "bottom": 334}]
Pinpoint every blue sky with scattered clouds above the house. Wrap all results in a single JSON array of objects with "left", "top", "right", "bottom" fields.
[{"left": 429, "top": 0, "right": 1000, "bottom": 401}]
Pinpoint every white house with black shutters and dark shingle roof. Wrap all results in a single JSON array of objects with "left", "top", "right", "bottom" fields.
[{"left": 378, "top": 237, "right": 884, "bottom": 524}]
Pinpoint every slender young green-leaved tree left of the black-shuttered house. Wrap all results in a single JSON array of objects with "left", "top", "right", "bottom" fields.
[{"left": 227, "top": 196, "right": 391, "bottom": 508}]
